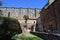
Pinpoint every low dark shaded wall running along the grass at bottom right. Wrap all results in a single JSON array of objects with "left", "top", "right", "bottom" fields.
[{"left": 30, "top": 32, "right": 60, "bottom": 40}]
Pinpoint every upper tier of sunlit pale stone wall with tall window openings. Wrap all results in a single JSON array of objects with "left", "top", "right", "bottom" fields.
[{"left": 0, "top": 8, "right": 40, "bottom": 19}]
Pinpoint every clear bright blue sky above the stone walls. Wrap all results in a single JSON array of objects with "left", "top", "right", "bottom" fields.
[{"left": 0, "top": 0, "right": 48, "bottom": 9}]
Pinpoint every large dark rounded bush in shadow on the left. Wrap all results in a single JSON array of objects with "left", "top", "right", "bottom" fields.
[{"left": 0, "top": 17, "right": 22, "bottom": 40}]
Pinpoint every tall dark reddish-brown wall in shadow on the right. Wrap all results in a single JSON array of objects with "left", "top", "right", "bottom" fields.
[{"left": 40, "top": 0, "right": 60, "bottom": 33}]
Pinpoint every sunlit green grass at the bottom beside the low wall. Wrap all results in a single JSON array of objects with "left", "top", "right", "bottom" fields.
[{"left": 12, "top": 33, "right": 43, "bottom": 40}]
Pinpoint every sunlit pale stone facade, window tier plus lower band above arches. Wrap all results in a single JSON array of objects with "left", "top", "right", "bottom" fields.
[{"left": 0, "top": 7, "right": 41, "bottom": 32}]
